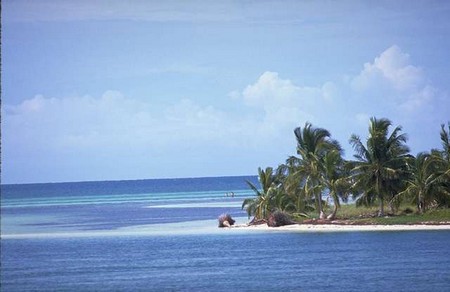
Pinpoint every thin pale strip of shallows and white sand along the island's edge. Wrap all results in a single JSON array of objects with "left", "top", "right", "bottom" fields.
[{"left": 4, "top": 217, "right": 450, "bottom": 240}]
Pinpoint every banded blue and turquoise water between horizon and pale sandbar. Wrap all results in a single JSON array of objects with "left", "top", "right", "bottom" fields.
[{"left": 1, "top": 177, "right": 255, "bottom": 237}]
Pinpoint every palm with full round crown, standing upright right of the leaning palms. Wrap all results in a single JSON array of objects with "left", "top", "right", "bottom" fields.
[{"left": 350, "top": 117, "right": 409, "bottom": 216}]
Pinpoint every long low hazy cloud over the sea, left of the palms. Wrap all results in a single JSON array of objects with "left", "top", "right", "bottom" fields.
[{"left": 5, "top": 91, "right": 236, "bottom": 152}]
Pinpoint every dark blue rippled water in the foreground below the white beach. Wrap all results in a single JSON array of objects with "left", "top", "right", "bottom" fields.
[{"left": 2, "top": 231, "right": 450, "bottom": 291}]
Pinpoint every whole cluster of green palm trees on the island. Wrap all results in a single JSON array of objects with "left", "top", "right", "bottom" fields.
[{"left": 242, "top": 118, "right": 450, "bottom": 219}]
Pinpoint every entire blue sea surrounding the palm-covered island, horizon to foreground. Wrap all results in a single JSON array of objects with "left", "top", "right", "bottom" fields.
[{"left": 1, "top": 177, "right": 450, "bottom": 291}]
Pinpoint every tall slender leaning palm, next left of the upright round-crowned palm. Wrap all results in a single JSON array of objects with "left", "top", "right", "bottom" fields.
[{"left": 293, "top": 123, "right": 340, "bottom": 219}]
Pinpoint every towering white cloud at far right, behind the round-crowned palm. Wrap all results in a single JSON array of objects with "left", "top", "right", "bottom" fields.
[{"left": 342, "top": 45, "right": 449, "bottom": 160}]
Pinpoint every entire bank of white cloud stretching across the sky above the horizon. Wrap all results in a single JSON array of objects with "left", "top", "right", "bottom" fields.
[{"left": 2, "top": 45, "right": 449, "bottom": 183}]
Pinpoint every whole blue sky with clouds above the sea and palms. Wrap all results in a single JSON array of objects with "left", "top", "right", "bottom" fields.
[{"left": 1, "top": 0, "right": 450, "bottom": 184}]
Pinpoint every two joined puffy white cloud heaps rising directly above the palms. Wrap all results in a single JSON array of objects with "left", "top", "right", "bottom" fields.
[{"left": 230, "top": 45, "right": 447, "bottom": 160}]
